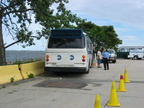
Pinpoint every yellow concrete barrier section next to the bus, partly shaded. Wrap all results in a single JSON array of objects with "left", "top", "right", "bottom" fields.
[{"left": 19, "top": 62, "right": 44, "bottom": 79}]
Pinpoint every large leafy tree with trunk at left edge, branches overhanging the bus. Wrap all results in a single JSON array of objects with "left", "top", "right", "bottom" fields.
[{"left": 0, "top": 0, "right": 84, "bottom": 65}]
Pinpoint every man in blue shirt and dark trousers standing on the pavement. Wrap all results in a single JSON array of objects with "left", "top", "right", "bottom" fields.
[{"left": 102, "top": 50, "right": 110, "bottom": 70}]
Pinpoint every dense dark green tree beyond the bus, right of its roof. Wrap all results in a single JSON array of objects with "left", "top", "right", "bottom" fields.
[{"left": 77, "top": 22, "right": 122, "bottom": 48}]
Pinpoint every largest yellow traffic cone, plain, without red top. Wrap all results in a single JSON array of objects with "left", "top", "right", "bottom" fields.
[{"left": 107, "top": 81, "right": 120, "bottom": 106}]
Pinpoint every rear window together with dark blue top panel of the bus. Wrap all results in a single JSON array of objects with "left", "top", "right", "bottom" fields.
[{"left": 48, "top": 29, "right": 85, "bottom": 48}]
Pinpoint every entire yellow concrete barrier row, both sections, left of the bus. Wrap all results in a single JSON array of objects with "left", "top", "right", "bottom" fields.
[{"left": 0, "top": 62, "right": 44, "bottom": 84}]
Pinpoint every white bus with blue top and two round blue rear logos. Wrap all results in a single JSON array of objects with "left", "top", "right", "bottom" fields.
[{"left": 45, "top": 29, "right": 93, "bottom": 73}]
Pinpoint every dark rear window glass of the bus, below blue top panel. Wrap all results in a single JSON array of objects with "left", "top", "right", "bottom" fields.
[{"left": 48, "top": 37, "right": 84, "bottom": 48}]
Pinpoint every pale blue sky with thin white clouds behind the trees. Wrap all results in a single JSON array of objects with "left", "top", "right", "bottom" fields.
[{"left": 4, "top": 0, "right": 144, "bottom": 50}]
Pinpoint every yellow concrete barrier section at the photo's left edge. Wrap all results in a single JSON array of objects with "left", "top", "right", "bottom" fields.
[{"left": 0, "top": 65, "right": 22, "bottom": 84}]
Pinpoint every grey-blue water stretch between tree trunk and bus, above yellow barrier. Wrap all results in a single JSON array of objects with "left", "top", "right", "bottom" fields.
[{"left": 6, "top": 50, "right": 45, "bottom": 62}]
